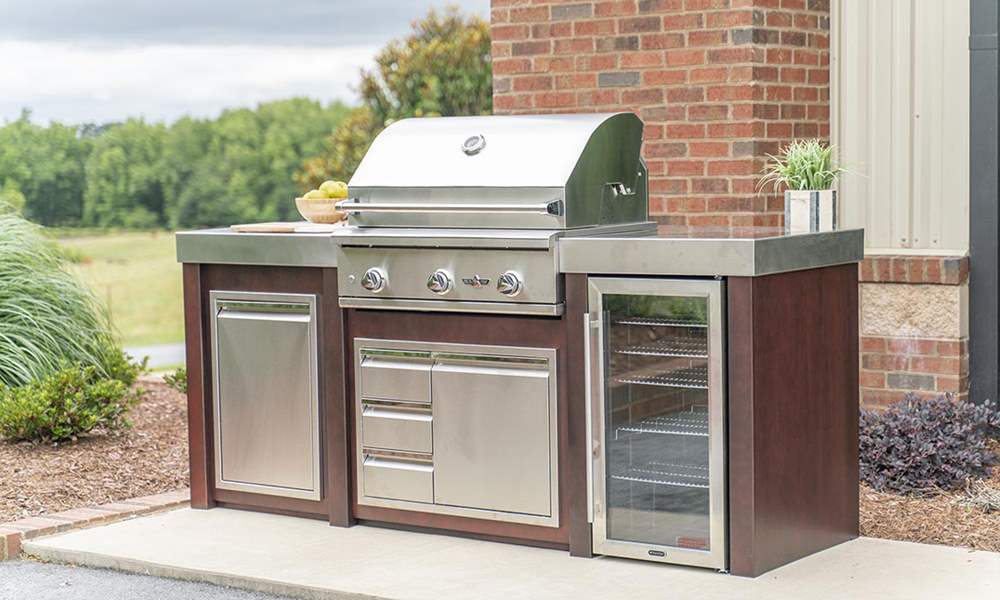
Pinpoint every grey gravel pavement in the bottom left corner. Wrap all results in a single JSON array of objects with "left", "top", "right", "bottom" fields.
[{"left": 0, "top": 560, "right": 292, "bottom": 600}]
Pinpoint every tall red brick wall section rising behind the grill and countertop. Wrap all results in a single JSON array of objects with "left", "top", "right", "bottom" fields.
[{"left": 492, "top": 0, "right": 829, "bottom": 226}]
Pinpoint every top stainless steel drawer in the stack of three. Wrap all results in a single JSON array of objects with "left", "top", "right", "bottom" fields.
[{"left": 361, "top": 350, "right": 431, "bottom": 403}]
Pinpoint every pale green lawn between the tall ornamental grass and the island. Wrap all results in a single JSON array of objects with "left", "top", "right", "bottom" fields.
[{"left": 59, "top": 231, "right": 184, "bottom": 346}]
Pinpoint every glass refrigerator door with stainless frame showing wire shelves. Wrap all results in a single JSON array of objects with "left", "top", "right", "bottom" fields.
[{"left": 590, "top": 279, "right": 725, "bottom": 569}]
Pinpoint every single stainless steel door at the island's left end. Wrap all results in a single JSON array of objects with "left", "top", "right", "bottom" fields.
[{"left": 210, "top": 291, "right": 321, "bottom": 500}]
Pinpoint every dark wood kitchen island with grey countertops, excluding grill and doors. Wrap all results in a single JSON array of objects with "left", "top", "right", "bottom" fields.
[{"left": 177, "top": 221, "right": 862, "bottom": 575}]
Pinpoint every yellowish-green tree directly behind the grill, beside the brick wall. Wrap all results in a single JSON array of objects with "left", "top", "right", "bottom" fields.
[{"left": 295, "top": 8, "right": 493, "bottom": 189}]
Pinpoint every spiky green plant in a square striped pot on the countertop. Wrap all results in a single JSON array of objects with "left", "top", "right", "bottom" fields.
[{"left": 758, "top": 139, "right": 844, "bottom": 233}]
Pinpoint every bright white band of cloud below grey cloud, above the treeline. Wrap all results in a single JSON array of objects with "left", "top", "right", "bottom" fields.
[{"left": 0, "top": 41, "right": 381, "bottom": 123}]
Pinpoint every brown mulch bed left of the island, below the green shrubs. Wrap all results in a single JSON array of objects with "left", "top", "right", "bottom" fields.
[{"left": 0, "top": 382, "right": 188, "bottom": 523}]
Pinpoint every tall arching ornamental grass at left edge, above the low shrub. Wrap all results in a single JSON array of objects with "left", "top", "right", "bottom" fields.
[{"left": 0, "top": 211, "right": 123, "bottom": 387}]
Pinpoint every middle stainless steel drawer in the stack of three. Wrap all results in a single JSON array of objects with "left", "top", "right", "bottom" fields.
[{"left": 361, "top": 400, "right": 432, "bottom": 454}]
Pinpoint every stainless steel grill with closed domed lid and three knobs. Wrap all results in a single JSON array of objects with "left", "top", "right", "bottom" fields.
[{"left": 334, "top": 113, "right": 655, "bottom": 315}]
